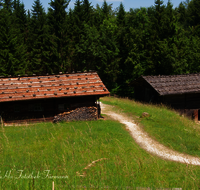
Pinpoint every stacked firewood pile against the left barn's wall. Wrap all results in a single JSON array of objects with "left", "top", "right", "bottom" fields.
[{"left": 53, "top": 106, "right": 97, "bottom": 123}]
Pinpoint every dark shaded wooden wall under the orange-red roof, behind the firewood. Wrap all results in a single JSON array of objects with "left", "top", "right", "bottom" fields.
[{"left": 0, "top": 96, "right": 97, "bottom": 122}]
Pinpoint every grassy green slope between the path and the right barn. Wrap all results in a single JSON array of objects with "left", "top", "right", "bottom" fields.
[{"left": 102, "top": 97, "right": 200, "bottom": 157}]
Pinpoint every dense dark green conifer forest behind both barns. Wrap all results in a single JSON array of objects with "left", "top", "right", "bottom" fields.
[{"left": 0, "top": 0, "right": 200, "bottom": 97}]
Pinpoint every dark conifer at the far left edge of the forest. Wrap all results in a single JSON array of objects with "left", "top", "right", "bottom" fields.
[{"left": 0, "top": 1, "right": 25, "bottom": 75}]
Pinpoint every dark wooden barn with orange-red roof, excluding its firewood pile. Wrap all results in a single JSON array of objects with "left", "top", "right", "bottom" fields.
[{"left": 0, "top": 72, "right": 109, "bottom": 124}]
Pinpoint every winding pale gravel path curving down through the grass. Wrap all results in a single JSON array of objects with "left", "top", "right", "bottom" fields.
[{"left": 101, "top": 103, "right": 200, "bottom": 165}]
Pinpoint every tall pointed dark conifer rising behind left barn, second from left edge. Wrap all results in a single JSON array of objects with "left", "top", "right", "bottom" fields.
[{"left": 29, "top": 0, "right": 51, "bottom": 74}]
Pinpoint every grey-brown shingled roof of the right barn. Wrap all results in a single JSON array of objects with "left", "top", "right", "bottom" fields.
[{"left": 136, "top": 73, "right": 200, "bottom": 95}]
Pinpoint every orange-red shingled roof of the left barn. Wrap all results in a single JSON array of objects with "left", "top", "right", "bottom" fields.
[{"left": 0, "top": 72, "right": 109, "bottom": 102}]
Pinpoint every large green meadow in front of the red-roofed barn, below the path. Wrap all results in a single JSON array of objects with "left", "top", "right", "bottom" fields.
[{"left": 0, "top": 120, "right": 200, "bottom": 190}]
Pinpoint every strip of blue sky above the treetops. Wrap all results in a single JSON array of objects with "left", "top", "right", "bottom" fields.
[{"left": 21, "top": 0, "right": 185, "bottom": 12}]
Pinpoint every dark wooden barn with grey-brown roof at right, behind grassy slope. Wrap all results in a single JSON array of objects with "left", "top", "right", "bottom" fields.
[{"left": 133, "top": 74, "right": 200, "bottom": 120}]
